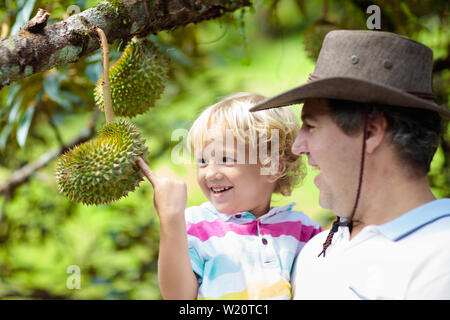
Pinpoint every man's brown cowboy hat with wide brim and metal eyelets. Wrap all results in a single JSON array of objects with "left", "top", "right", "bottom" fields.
[{"left": 250, "top": 30, "right": 450, "bottom": 118}]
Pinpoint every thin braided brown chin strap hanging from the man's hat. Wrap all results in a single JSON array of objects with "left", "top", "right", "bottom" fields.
[{"left": 318, "top": 105, "right": 369, "bottom": 258}]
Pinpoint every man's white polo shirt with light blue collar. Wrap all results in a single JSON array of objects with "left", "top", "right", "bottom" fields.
[{"left": 292, "top": 199, "right": 450, "bottom": 299}]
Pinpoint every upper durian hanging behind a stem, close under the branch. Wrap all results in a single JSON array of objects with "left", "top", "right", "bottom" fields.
[{"left": 94, "top": 39, "right": 168, "bottom": 118}]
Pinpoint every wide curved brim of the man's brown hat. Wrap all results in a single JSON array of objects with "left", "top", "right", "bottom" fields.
[{"left": 250, "top": 77, "right": 450, "bottom": 118}]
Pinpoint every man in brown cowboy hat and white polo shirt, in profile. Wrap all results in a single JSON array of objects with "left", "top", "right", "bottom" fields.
[{"left": 251, "top": 30, "right": 450, "bottom": 299}]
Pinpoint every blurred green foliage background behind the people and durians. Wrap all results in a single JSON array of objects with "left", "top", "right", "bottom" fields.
[{"left": 0, "top": 0, "right": 450, "bottom": 299}]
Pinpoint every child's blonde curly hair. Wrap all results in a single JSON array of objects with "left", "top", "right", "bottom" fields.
[{"left": 187, "top": 92, "right": 305, "bottom": 196}]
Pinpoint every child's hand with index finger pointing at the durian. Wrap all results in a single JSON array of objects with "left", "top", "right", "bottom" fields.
[{"left": 136, "top": 157, "right": 187, "bottom": 222}]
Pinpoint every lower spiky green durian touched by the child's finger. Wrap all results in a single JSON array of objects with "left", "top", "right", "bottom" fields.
[{"left": 56, "top": 119, "right": 148, "bottom": 205}]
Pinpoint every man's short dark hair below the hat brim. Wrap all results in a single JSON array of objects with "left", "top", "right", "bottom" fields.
[{"left": 328, "top": 99, "right": 442, "bottom": 176}]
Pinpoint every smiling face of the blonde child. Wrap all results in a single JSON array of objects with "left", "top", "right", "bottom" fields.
[{"left": 196, "top": 140, "right": 277, "bottom": 217}]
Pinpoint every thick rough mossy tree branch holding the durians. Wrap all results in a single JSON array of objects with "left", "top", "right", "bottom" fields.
[{"left": 0, "top": 0, "right": 251, "bottom": 89}]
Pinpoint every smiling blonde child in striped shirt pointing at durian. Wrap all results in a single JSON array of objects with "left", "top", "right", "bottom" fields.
[{"left": 140, "top": 93, "right": 322, "bottom": 299}]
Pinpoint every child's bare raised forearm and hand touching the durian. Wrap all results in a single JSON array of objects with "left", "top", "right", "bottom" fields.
[{"left": 137, "top": 159, "right": 198, "bottom": 299}]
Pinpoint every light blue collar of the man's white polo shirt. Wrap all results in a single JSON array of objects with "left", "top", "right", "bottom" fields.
[{"left": 377, "top": 199, "right": 450, "bottom": 241}]
